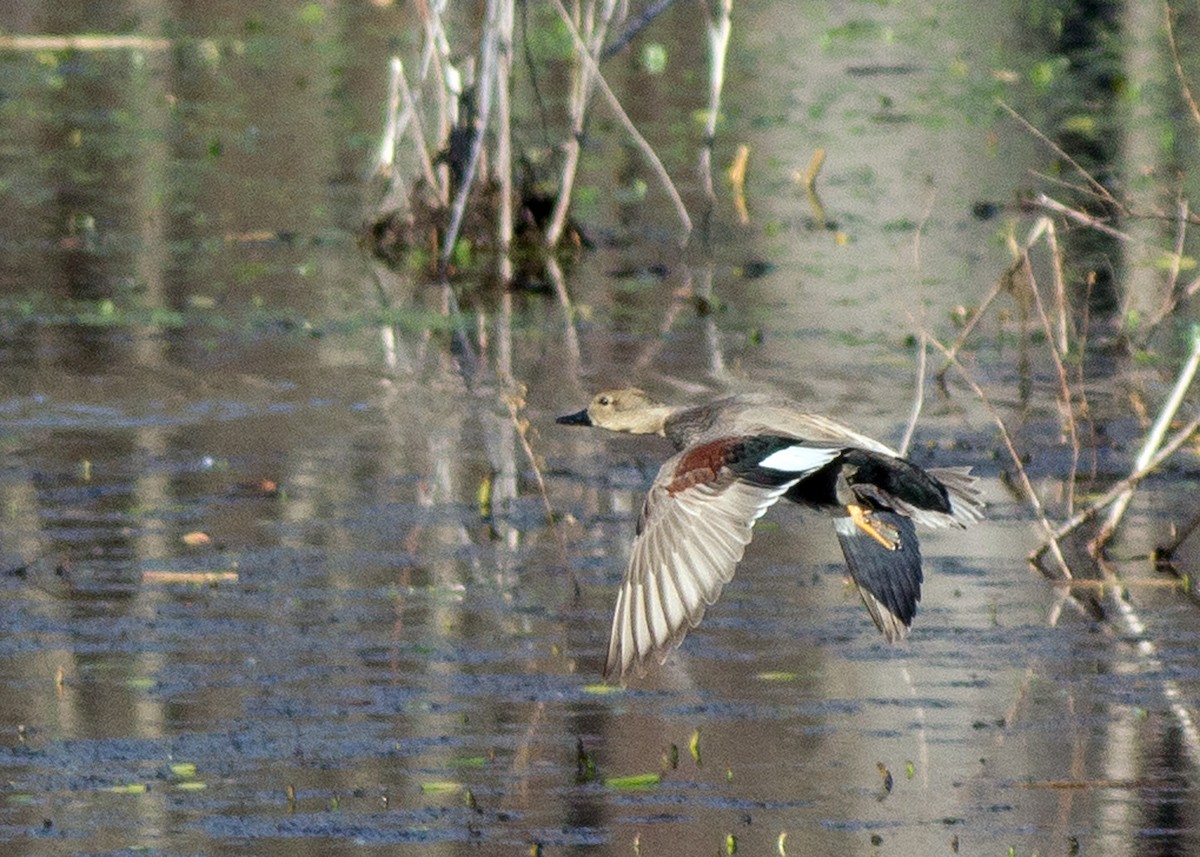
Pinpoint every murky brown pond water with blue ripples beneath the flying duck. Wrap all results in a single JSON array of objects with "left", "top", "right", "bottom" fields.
[{"left": 0, "top": 4, "right": 1200, "bottom": 855}]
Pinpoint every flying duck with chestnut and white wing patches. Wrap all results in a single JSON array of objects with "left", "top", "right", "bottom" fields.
[{"left": 558, "top": 388, "right": 983, "bottom": 682}]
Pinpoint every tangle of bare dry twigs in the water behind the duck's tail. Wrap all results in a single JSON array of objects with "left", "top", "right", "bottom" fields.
[{"left": 931, "top": 93, "right": 1200, "bottom": 763}]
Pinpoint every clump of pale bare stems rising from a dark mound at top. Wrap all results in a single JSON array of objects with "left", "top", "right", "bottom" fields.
[{"left": 370, "top": 0, "right": 732, "bottom": 271}]
